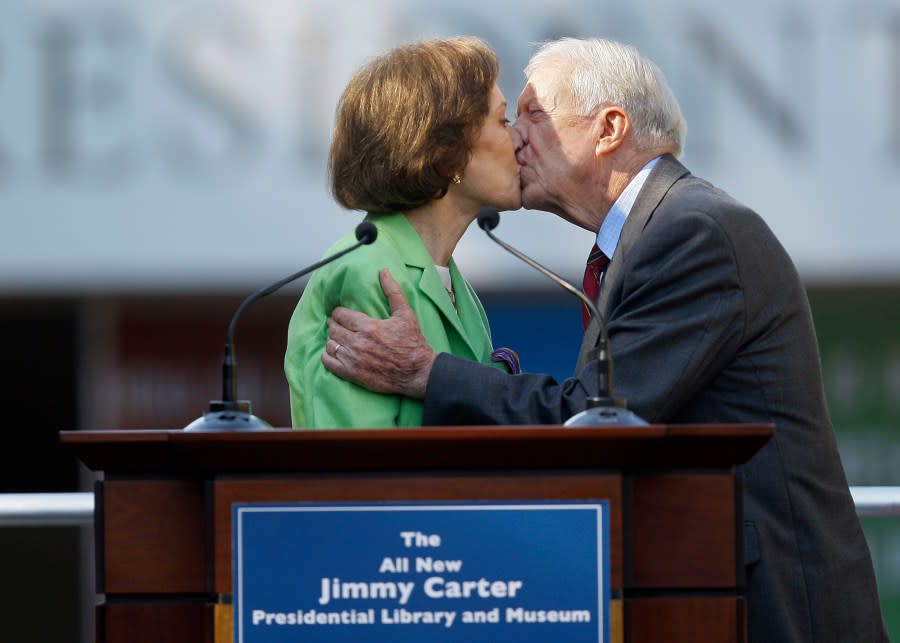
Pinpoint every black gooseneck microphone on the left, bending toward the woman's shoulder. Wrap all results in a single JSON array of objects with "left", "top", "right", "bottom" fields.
[{"left": 184, "top": 221, "right": 378, "bottom": 431}]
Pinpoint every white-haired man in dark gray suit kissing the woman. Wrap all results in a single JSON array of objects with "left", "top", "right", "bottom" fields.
[{"left": 322, "top": 39, "right": 887, "bottom": 643}]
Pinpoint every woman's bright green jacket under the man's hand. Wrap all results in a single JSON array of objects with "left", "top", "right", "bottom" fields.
[{"left": 284, "top": 214, "right": 502, "bottom": 428}]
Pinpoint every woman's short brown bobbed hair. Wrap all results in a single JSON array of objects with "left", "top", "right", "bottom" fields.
[{"left": 328, "top": 37, "right": 500, "bottom": 214}]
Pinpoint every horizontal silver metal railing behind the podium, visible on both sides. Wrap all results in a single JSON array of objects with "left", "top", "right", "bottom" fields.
[{"left": 0, "top": 487, "right": 900, "bottom": 527}]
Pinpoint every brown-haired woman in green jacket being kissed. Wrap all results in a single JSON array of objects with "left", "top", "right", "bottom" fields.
[{"left": 285, "top": 37, "right": 521, "bottom": 428}]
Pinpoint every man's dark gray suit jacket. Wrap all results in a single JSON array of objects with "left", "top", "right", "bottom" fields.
[{"left": 424, "top": 156, "right": 887, "bottom": 643}]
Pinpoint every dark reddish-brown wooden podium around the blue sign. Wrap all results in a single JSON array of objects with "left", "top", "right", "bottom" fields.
[{"left": 61, "top": 424, "right": 772, "bottom": 643}]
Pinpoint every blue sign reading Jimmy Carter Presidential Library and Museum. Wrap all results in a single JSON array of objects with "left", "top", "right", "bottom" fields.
[{"left": 232, "top": 500, "right": 609, "bottom": 643}]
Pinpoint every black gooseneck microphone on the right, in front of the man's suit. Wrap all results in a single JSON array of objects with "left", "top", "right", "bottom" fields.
[{"left": 478, "top": 207, "right": 647, "bottom": 427}]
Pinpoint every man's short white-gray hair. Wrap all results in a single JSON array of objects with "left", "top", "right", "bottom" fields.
[{"left": 525, "top": 38, "right": 687, "bottom": 156}]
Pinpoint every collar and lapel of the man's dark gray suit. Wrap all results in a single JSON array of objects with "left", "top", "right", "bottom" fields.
[{"left": 575, "top": 154, "right": 689, "bottom": 375}]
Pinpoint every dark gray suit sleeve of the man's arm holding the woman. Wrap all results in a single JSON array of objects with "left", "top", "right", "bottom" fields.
[{"left": 424, "top": 211, "right": 743, "bottom": 424}]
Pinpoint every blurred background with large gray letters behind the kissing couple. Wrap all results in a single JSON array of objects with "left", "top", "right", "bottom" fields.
[{"left": 0, "top": 0, "right": 900, "bottom": 643}]
